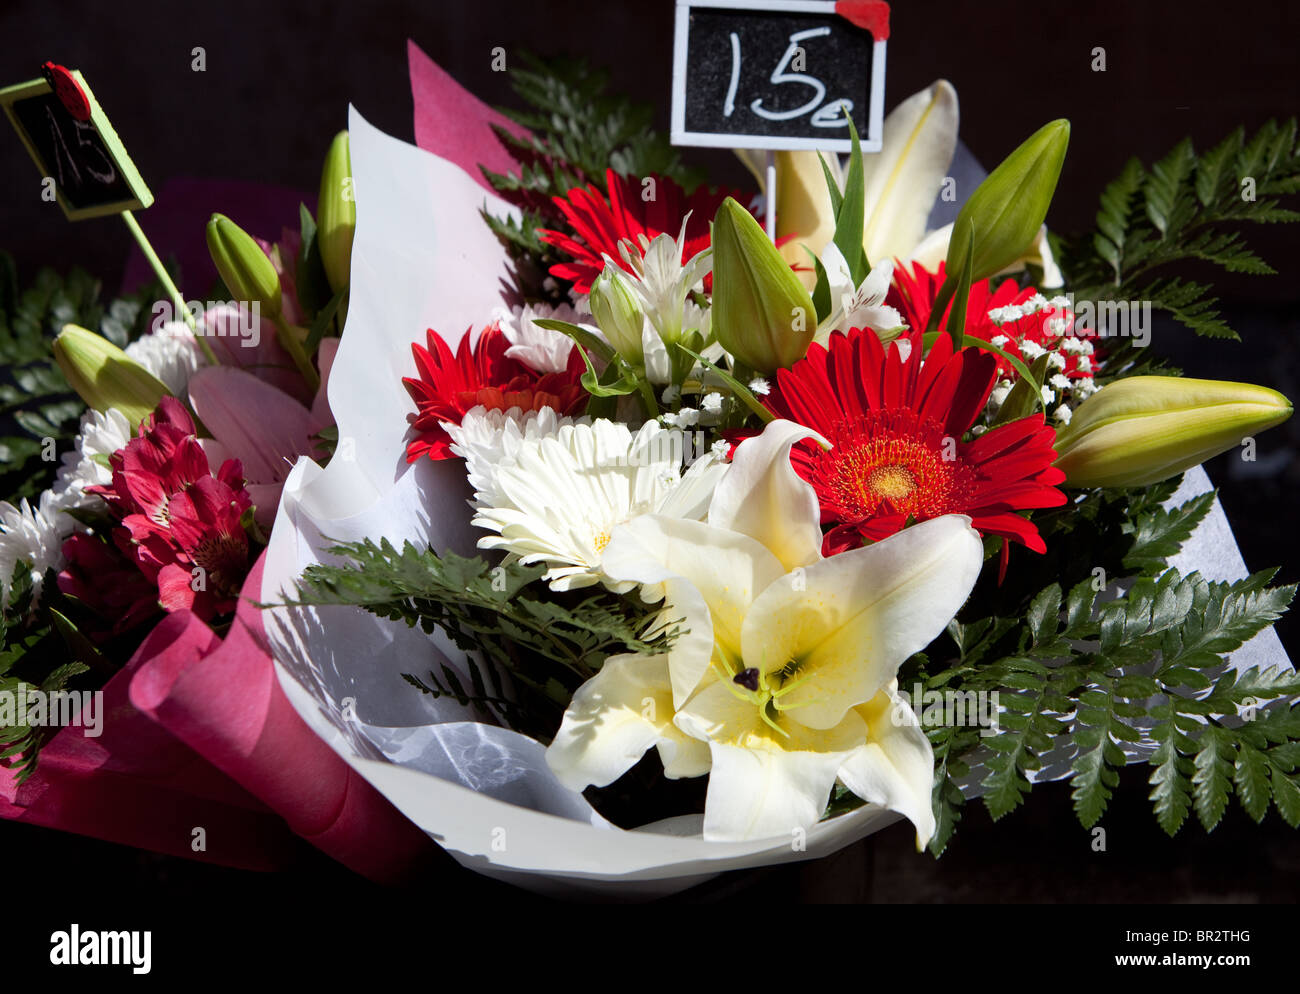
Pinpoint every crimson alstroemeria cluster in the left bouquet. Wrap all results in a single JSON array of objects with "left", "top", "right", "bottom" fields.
[{"left": 90, "top": 396, "right": 252, "bottom": 621}]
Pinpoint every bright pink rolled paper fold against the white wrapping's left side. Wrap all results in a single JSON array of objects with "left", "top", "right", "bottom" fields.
[{"left": 130, "top": 550, "right": 434, "bottom": 884}]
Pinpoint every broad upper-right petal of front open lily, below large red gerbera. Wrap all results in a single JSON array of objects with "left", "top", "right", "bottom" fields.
[{"left": 741, "top": 515, "right": 984, "bottom": 729}]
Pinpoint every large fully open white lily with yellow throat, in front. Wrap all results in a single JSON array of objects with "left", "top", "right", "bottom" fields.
[{"left": 547, "top": 421, "right": 983, "bottom": 846}]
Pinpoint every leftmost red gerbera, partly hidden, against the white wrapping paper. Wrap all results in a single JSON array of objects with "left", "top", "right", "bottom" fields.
[{"left": 402, "top": 324, "right": 586, "bottom": 463}]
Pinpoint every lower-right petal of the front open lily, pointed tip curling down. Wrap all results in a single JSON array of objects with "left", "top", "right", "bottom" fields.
[{"left": 840, "top": 681, "right": 935, "bottom": 852}]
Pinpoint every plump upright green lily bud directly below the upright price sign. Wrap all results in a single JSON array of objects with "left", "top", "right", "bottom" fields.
[{"left": 712, "top": 198, "right": 816, "bottom": 376}]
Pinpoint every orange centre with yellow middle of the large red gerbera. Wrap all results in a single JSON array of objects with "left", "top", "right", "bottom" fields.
[{"left": 814, "top": 411, "right": 976, "bottom": 521}]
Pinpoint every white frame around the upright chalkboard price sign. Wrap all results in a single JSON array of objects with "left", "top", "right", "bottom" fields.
[{"left": 671, "top": 0, "right": 888, "bottom": 152}]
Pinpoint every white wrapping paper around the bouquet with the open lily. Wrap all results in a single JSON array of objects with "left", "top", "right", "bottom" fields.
[{"left": 263, "top": 109, "right": 1286, "bottom": 898}]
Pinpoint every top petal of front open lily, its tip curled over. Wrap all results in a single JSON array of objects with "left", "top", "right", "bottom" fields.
[{"left": 709, "top": 421, "right": 829, "bottom": 569}]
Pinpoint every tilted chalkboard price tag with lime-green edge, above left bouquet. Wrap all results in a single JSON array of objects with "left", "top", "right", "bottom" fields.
[{"left": 0, "top": 62, "right": 153, "bottom": 221}]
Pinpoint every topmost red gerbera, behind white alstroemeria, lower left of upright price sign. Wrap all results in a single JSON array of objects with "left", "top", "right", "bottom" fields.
[{"left": 537, "top": 169, "right": 745, "bottom": 294}]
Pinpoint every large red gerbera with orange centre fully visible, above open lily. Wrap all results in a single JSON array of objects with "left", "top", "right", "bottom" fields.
[{"left": 766, "top": 329, "right": 1065, "bottom": 568}]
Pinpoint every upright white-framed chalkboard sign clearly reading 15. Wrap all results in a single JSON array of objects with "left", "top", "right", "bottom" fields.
[{"left": 672, "top": 0, "right": 889, "bottom": 152}]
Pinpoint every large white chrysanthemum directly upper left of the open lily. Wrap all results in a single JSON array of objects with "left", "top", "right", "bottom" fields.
[{"left": 475, "top": 418, "right": 727, "bottom": 590}]
